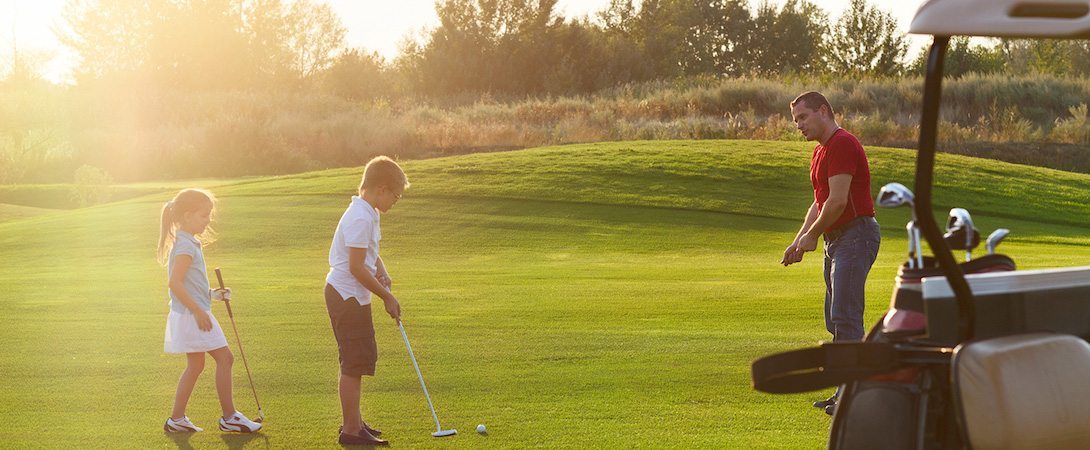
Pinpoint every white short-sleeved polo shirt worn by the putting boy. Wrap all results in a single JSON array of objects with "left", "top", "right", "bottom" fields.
[{"left": 326, "top": 195, "right": 383, "bottom": 305}]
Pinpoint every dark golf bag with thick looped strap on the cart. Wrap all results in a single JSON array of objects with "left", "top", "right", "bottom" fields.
[{"left": 752, "top": 255, "right": 1015, "bottom": 449}]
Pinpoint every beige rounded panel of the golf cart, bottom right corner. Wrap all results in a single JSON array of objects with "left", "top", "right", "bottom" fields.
[{"left": 952, "top": 333, "right": 1090, "bottom": 449}]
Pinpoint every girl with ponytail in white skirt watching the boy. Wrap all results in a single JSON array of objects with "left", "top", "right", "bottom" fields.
[{"left": 157, "top": 188, "right": 262, "bottom": 433}]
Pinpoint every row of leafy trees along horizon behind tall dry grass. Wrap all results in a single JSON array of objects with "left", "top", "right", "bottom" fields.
[{"left": 17, "top": 0, "right": 1090, "bottom": 100}]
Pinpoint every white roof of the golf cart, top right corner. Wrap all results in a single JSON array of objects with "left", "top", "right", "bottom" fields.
[{"left": 909, "top": 0, "right": 1090, "bottom": 38}]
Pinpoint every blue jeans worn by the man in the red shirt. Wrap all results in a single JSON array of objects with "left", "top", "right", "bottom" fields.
[{"left": 825, "top": 218, "right": 882, "bottom": 341}]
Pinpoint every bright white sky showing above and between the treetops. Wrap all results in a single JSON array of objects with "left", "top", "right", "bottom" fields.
[{"left": 0, "top": 0, "right": 928, "bottom": 82}]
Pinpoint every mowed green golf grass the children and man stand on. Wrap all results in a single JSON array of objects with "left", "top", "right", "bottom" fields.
[{"left": 0, "top": 141, "right": 1090, "bottom": 449}]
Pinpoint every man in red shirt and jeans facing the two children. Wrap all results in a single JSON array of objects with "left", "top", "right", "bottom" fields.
[{"left": 780, "top": 92, "right": 882, "bottom": 414}]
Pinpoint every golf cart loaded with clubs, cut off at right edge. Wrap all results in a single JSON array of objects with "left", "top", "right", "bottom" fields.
[{"left": 752, "top": 0, "right": 1090, "bottom": 449}]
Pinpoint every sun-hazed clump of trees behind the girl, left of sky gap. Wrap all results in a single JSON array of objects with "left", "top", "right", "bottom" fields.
[{"left": 60, "top": 0, "right": 344, "bottom": 89}]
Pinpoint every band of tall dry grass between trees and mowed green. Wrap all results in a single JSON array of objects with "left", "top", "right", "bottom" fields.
[{"left": 6, "top": 75, "right": 1090, "bottom": 183}]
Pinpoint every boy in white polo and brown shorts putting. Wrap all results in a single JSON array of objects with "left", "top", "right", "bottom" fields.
[{"left": 326, "top": 156, "right": 409, "bottom": 446}]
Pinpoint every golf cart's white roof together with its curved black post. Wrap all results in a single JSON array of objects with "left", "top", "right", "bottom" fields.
[{"left": 909, "top": 0, "right": 1090, "bottom": 341}]
